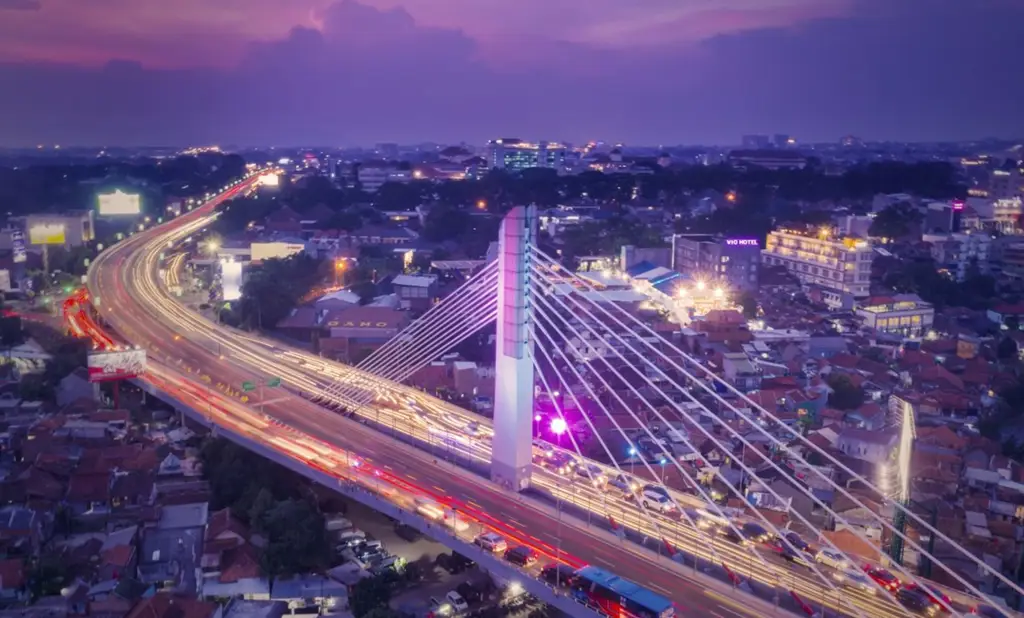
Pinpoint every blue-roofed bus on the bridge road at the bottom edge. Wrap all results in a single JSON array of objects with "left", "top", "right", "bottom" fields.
[{"left": 572, "top": 567, "right": 676, "bottom": 618}]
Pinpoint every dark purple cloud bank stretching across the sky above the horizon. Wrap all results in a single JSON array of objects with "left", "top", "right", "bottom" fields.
[{"left": 0, "top": 0, "right": 1024, "bottom": 145}]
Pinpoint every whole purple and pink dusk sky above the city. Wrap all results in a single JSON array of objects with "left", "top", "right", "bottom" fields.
[{"left": 0, "top": 0, "right": 1024, "bottom": 145}]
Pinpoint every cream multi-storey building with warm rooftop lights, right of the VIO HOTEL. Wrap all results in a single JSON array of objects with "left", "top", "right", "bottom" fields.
[{"left": 761, "top": 228, "right": 874, "bottom": 306}]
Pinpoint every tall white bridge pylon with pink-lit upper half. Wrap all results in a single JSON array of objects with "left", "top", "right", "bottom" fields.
[{"left": 490, "top": 206, "right": 536, "bottom": 491}]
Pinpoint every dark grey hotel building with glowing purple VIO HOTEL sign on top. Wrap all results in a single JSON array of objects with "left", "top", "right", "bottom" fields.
[{"left": 672, "top": 234, "right": 761, "bottom": 290}]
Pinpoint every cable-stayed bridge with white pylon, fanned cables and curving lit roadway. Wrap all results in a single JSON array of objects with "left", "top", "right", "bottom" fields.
[{"left": 79, "top": 188, "right": 1017, "bottom": 616}]
